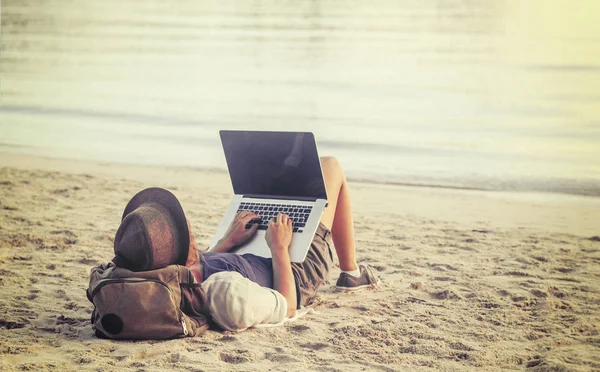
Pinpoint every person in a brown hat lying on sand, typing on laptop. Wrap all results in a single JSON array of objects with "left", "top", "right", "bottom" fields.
[{"left": 113, "top": 157, "right": 378, "bottom": 330}]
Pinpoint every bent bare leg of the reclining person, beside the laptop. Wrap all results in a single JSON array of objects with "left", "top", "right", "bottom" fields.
[{"left": 321, "top": 157, "right": 358, "bottom": 271}]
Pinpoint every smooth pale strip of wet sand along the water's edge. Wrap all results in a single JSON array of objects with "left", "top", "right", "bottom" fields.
[{"left": 0, "top": 152, "right": 600, "bottom": 237}]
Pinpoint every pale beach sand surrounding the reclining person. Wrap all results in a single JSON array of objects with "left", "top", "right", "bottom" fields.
[{"left": 0, "top": 154, "right": 600, "bottom": 371}]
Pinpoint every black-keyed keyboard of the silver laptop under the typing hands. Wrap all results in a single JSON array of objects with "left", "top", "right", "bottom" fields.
[{"left": 238, "top": 202, "right": 312, "bottom": 232}]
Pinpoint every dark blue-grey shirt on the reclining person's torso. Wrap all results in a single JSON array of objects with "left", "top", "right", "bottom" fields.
[{"left": 200, "top": 252, "right": 300, "bottom": 308}]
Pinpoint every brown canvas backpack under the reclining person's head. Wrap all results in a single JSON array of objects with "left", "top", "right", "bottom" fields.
[{"left": 86, "top": 262, "right": 209, "bottom": 340}]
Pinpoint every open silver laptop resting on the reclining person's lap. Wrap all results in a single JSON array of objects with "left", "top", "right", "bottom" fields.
[{"left": 211, "top": 130, "right": 327, "bottom": 262}]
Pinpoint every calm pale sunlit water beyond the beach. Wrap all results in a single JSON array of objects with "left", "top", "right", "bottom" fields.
[{"left": 0, "top": 0, "right": 600, "bottom": 196}]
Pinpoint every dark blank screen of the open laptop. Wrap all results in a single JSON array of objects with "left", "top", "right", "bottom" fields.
[{"left": 220, "top": 131, "right": 327, "bottom": 199}]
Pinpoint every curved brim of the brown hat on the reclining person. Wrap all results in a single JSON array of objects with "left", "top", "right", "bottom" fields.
[{"left": 113, "top": 187, "right": 190, "bottom": 266}]
